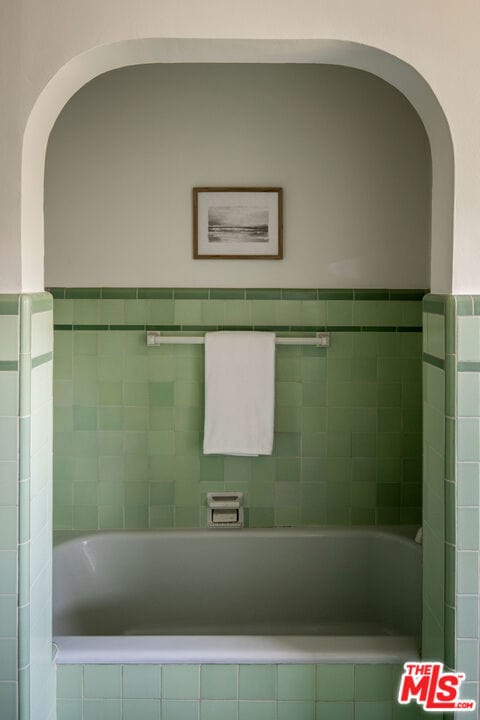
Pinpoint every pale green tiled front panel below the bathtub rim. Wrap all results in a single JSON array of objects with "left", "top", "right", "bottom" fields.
[{"left": 57, "top": 664, "right": 427, "bottom": 720}]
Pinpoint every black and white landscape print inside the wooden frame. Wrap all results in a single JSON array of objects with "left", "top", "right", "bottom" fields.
[{"left": 208, "top": 205, "right": 270, "bottom": 244}]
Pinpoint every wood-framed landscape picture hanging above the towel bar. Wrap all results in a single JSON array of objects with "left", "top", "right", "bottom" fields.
[{"left": 193, "top": 187, "right": 283, "bottom": 260}]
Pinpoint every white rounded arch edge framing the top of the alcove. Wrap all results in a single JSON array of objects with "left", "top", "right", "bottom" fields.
[{"left": 21, "top": 38, "right": 454, "bottom": 293}]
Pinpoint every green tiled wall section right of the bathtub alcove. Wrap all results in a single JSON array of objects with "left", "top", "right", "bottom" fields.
[{"left": 423, "top": 295, "right": 480, "bottom": 716}]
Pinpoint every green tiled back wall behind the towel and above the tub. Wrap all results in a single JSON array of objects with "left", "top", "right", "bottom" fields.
[{"left": 52, "top": 288, "right": 423, "bottom": 530}]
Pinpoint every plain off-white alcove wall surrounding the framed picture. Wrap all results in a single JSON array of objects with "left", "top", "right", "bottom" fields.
[{"left": 45, "top": 64, "right": 431, "bottom": 287}]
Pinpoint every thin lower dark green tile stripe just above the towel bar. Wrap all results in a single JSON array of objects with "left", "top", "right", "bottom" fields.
[{"left": 53, "top": 324, "right": 422, "bottom": 335}]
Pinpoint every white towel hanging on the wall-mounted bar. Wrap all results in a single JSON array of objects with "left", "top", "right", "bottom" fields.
[{"left": 203, "top": 332, "right": 275, "bottom": 455}]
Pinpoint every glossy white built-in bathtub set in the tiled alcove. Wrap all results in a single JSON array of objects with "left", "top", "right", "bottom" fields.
[{"left": 53, "top": 528, "right": 421, "bottom": 663}]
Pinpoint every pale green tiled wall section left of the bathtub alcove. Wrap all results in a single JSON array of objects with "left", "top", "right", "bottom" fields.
[{"left": 0, "top": 293, "right": 55, "bottom": 720}]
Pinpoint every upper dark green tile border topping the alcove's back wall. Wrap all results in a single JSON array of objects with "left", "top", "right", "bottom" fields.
[{"left": 47, "top": 288, "right": 428, "bottom": 302}]
